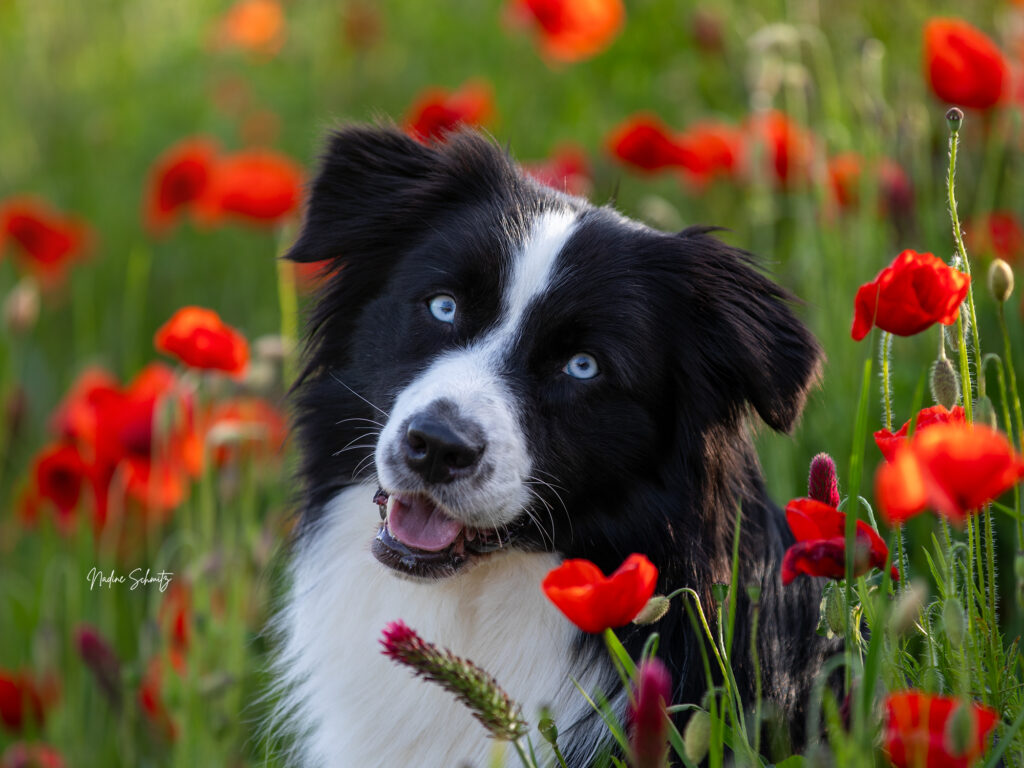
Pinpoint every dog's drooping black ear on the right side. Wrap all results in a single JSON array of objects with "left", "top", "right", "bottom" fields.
[{"left": 679, "top": 228, "right": 823, "bottom": 432}]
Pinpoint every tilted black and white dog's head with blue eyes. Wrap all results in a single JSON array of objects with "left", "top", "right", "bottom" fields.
[{"left": 289, "top": 127, "right": 820, "bottom": 578}]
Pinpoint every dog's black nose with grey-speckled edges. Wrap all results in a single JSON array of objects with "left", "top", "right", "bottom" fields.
[{"left": 402, "top": 413, "right": 484, "bottom": 482}]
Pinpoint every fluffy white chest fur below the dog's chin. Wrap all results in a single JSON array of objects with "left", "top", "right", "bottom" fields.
[{"left": 279, "top": 485, "right": 606, "bottom": 768}]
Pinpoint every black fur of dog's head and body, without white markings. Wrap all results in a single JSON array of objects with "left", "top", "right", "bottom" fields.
[{"left": 289, "top": 127, "right": 835, "bottom": 755}]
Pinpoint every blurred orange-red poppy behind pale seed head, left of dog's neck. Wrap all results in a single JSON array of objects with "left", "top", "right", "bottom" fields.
[{"left": 204, "top": 397, "right": 288, "bottom": 466}]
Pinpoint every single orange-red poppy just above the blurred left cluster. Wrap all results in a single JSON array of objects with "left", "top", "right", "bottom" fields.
[{"left": 154, "top": 306, "right": 249, "bottom": 374}]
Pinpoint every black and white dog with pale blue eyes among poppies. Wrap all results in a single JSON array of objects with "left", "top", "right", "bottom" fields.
[{"left": 280, "top": 127, "right": 826, "bottom": 768}]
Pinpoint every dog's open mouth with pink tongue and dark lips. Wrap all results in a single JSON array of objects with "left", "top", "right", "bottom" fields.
[{"left": 372, "top": 489, "right": 512, "bottom": 579}]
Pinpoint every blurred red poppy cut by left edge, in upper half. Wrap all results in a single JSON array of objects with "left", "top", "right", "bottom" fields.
[{"left": 0, "top": 197, "right": 91, "bottom": 286}]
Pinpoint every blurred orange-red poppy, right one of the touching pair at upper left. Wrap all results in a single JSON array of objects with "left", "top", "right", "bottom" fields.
[{"left": 196, "top": 150, "right": 302, "bottom": 225}]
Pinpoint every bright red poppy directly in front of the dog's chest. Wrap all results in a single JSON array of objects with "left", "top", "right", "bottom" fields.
[{"left": 541, "top": 554, "right": 657, "bottom": 632}]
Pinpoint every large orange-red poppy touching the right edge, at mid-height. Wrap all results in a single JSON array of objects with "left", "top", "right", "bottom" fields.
[{"left": 874, "top": 423, "right": 1024, "bottom": 522}]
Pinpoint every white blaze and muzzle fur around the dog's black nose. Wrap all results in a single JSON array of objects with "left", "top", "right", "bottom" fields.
[{"left": 375, "top": 210, "right": 577, "bottom": 527}]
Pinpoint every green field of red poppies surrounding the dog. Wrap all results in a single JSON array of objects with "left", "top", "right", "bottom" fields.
[{"left": 0, "top": 0, "right": 1024, "bottom": 768}]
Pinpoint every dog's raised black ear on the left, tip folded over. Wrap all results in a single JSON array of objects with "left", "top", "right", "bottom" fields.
[{"left": 288, "top": 126, "right": 438, "bottom": 261}]
